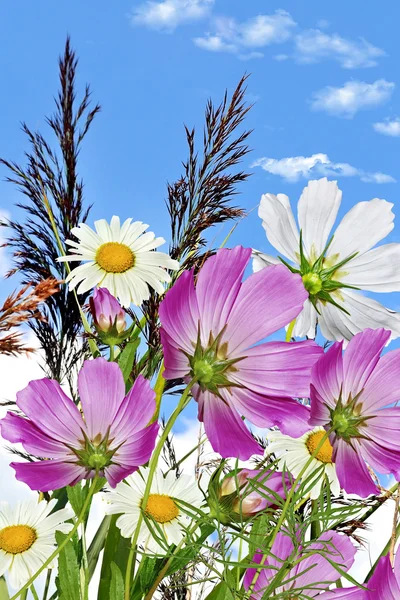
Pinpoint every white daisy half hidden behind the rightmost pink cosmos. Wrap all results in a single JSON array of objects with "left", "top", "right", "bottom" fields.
[{"left": 267, "top": 427, "right": 340, "bottom": 500}]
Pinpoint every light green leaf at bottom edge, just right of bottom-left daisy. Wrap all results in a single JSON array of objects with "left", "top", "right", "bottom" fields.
[{"left": 56, "top": 531, "right": 81, "bottom": 600}]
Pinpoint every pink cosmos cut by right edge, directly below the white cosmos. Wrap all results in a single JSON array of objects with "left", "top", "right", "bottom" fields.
[{"left": 310, "top": 329, "right": 400, "bottom": 496}]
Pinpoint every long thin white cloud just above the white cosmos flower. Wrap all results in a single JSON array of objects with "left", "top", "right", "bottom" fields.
[{"left": 251, "top": 153, "right": 396, "bottom": 183}]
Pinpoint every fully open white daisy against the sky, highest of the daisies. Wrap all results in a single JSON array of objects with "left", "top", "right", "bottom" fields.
[{"left": 58, "top": 216, "right": 179, "bottom": 307}]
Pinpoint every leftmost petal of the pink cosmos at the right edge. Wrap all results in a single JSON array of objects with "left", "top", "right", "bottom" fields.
[{"left": 310, "top": 342, "right": 343, "bottom": 426}]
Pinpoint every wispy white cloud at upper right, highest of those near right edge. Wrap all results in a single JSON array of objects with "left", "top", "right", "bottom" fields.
[{"left": 295, "top": 29, "right": 386, "bottom": 69}]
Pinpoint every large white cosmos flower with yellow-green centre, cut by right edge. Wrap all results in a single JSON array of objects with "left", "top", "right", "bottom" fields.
[{"left": 253, "top": 178, "right": 400, "bottom": 341}]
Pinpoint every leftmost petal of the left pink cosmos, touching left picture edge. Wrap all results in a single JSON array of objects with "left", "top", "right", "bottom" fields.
[{"left": 0, "top": 412, "right": 69, "bottom": 458}]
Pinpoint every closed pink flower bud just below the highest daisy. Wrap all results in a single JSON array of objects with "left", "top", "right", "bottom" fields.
[{"left": 90, "top": 288, "right": 126, "bottom": 337}]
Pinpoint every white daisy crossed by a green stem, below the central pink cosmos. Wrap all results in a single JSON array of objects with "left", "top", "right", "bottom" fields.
[{"left": 104, "top": 469, "right": 203, "bottom": 553}]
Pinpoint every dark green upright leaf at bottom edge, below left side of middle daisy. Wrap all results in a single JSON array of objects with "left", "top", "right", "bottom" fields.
[{"left": 97, "top": 515, "right": 130, "bottom": 600}]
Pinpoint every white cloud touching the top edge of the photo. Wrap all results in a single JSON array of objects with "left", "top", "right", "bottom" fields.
[{"left": 132, "top": 0, "right": 214, "bottom": 31}]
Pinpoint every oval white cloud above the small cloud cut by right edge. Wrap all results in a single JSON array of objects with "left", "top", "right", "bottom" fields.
[{"left": 312, "top": 79, "right": 395, "bottom": 119}]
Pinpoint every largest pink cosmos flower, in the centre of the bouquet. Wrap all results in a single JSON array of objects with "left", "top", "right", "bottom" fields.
[{"left": 160, "top": 246, "right": 322, "bottom": 460}]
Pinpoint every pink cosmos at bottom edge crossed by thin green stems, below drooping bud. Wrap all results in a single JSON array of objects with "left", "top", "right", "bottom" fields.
[{"left": 243, "top": 531, "right": 356, "bottom": 600}]
